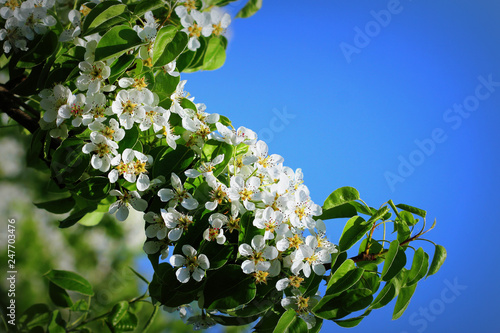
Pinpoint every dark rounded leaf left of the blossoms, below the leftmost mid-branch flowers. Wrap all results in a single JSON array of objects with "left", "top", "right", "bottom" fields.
[{"left": 50, "top": 138, "right": 90, "bottom": 184}]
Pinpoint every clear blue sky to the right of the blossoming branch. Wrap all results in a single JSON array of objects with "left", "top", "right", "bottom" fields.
[{"left": 144, "top": 0, "right": 500, "bottom": 333}]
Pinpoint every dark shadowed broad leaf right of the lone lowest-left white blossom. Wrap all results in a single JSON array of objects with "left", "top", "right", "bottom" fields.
[{"left": 203, "top": 265, "right": 256, "bottom": 310}]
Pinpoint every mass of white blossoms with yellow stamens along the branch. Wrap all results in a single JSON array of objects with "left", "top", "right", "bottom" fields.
[{"left": 4, "top": 0, "right": 336, "bottom": 330}]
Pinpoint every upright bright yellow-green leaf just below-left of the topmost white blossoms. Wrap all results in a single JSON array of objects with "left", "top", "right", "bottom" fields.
[{"left": 153, "top": 26, "right": 189, "bottom": 67}]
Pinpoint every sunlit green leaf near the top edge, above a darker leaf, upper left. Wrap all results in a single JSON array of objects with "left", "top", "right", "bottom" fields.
[{"left": 82, "top": 1, "right": 129, "bottom": 35}]
